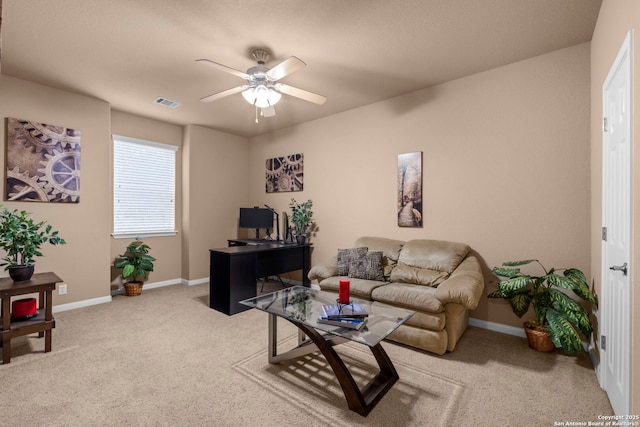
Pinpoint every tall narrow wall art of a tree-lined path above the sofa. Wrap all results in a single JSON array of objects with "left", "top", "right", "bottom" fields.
[{"left": 397, "top": 151, "right": 423, "bottom": 227}]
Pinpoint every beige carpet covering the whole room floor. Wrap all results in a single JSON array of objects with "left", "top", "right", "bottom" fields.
[{"left": 0, "top": 285, "right": 612, "bottom": 427}]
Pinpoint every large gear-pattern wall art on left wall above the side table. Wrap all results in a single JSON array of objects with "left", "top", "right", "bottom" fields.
[{"left": 5, "top": 117, "right": 80, "bottom": 203}]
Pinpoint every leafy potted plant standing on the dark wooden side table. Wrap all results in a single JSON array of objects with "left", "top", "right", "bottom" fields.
[{"left": 0, "top": 206, "right": 67, "bottom": 282}]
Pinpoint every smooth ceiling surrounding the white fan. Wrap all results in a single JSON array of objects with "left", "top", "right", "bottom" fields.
[{"left": 0, "top": 0, "right": 601, "bottom": 137}]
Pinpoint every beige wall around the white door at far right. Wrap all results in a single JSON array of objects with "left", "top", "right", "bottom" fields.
[{"left": 591, "top": 0, "right": 640, "bottom": 414}]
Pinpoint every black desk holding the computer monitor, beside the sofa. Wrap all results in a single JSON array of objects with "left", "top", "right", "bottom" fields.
[{"left": 209, "top": 240, "right": 311, "bottom": 315}]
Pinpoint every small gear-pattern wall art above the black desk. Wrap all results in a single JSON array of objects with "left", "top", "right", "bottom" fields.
[{"left": 265, "top": 153, "right": 304, "bottom": 193}]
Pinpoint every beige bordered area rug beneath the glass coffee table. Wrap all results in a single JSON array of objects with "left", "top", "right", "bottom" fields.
[{"left": 233, "top": 335, "right": 464, "bottom": 426}]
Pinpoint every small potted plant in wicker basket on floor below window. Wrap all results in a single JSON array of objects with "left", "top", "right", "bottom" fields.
[{"left": 113, "top": 239, "right": 156, "bottom": 297}]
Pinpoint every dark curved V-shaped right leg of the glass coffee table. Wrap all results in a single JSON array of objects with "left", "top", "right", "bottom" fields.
[{"left": 291, "top": 322, "right": 399, "bottom": 417}]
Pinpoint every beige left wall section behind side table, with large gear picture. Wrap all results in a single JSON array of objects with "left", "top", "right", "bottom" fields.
[{"left": 0, "top": 75, "right": 111, "bottom": 305}]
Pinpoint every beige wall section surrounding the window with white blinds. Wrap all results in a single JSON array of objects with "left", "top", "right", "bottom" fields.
[{"left": 108, "top": 111, "right": 182, "bottom": 289}]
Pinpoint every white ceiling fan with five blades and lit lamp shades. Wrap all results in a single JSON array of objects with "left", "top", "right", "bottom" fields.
[{"left": 196, "top": 49, "right": 327, "bottom": 123}]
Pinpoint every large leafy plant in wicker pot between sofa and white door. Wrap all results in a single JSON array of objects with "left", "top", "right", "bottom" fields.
[{"left": 488, "top": 259, "right": 598, "bottom": 353}]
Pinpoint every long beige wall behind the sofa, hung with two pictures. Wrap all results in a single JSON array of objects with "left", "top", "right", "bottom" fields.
[{"left": 249, "top": 44, "right": 590, "bottom": 326}]
